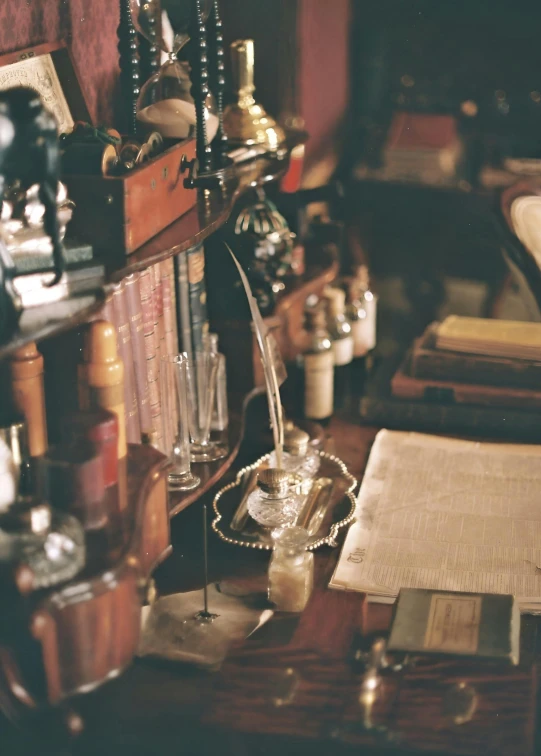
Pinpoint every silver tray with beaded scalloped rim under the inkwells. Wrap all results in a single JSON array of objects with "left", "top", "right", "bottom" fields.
[{"left": 212, "top": 451, "right": 357, "bottom": 551}]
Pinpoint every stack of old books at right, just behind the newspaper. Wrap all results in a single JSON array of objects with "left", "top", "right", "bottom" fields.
[{"left": 361, "top": 316, "right": 541, "bottom": 441}]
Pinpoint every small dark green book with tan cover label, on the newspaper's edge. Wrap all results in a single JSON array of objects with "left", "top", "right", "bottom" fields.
[{"left": 387, "top": 588, "right": 520, "bottom": 664}]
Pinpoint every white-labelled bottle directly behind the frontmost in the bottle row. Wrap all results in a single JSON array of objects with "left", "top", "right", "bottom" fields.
[{"left": 324, "top": 286, "right": 353, "bottom": 409}]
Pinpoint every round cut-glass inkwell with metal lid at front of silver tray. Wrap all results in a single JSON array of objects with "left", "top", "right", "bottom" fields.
[{"left": 248, "top": 467, "right": 305, "bottom": 528}]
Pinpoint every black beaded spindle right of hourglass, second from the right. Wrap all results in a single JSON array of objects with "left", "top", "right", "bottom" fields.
[{"left": 190, "top": 0, "right": 212, "bottom": 173}]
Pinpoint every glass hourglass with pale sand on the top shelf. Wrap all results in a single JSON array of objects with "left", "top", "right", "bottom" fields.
[{"left": 130, "top": 0, "right": 218, "bottom": 143}]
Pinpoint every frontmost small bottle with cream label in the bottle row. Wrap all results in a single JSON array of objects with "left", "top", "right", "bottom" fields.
[{"left": 302, "top": 304, "right": 334, "bottom": 423}]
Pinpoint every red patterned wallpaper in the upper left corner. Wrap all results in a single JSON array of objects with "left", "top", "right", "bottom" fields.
[{"left": 0, "top": 0, "right": 119, "bottom": 124}]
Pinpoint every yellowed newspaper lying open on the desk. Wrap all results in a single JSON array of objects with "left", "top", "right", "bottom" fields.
[{"left": 330, "top": 430, "right": 541, "bottom": 613}]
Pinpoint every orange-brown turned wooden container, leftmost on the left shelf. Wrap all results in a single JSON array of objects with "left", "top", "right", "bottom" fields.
[{"left": 10, "top": 342, "right": 47, "bottom": 457}]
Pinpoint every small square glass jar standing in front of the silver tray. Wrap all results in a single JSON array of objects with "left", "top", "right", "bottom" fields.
[{"left": 268, "top": 527, "right": 314, "bottom": 612}]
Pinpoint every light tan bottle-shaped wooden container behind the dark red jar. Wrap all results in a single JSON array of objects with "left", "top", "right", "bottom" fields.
[{"left": 79, "top": 320, "right": 127, "bottom": 459}]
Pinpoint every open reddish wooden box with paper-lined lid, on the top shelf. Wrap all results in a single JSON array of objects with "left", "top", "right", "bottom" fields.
[{"left": 0, "top": 43, "right": 197, "bottom": 257}]
